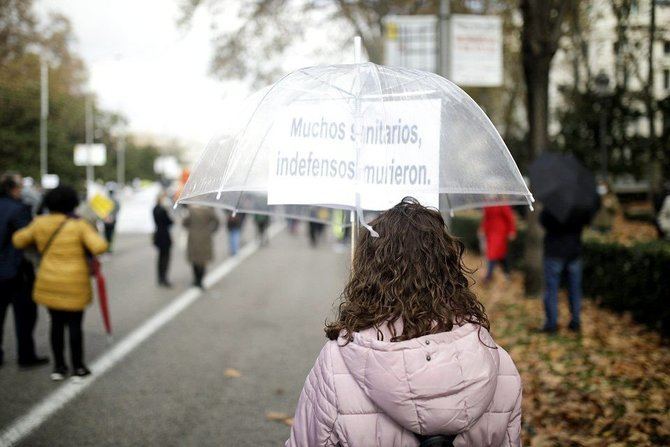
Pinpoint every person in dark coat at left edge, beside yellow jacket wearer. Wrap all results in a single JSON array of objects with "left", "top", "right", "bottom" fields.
[{"left": 0, "top": 174, "right": 49, "bottom": 367}]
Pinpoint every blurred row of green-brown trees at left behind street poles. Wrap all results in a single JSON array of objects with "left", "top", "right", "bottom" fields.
[{"left": 0, "top": 0, "right": 168, "bottom": 189}]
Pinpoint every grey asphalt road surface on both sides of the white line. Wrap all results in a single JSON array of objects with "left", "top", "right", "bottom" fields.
[{"left": 0, "top": 222, "right": 348, "bottom": 446}]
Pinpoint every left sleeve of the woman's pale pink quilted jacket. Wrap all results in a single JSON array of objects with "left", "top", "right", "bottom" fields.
[{"left": 286, "top": 342, "right": 338, "bottom": 447}]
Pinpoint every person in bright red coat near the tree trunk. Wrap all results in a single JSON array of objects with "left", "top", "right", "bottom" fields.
[{"left": 479, "top": 205, "right": 516, "bottom": 284}]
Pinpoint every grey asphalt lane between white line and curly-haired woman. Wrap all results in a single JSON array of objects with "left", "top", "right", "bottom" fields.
[{"left": 11, "top": 231, "right": 348, "bottom": 447}]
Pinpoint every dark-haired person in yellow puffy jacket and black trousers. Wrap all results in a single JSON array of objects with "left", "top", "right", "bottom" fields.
[{"left": 12, "top": 186, "right": 107, "bottom": 380}]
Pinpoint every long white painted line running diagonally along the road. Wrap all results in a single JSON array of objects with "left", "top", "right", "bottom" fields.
[{"left": 0, "top": 224, "right": 284, "bottom": 447}]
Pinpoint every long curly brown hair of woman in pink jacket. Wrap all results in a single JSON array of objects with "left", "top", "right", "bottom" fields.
[{"left": 324, "top": 197, "right": 490, "bottom": 342}]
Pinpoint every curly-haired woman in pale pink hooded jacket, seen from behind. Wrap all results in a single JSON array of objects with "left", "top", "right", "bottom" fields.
[{"left": 286, "top": 198, "right": 521, "bottom": 447}]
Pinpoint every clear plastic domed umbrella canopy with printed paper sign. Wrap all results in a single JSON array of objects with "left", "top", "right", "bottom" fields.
[{"left": 179, "top": 62, "right": 533, "bottom": 234}]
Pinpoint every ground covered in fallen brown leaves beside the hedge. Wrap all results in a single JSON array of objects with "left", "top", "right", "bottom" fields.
[{"left": 469, "top": 258, "right": 670, "bottom": 447}]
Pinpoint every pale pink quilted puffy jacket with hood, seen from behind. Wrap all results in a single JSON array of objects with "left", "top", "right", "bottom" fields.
[{"left": 286, "top": 324, "right": 521, "bottom": 447}]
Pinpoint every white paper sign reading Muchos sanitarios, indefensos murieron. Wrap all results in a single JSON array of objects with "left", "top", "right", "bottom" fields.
[{"left": 266, "top": 99, "right": 440, "bottom": 210}]
